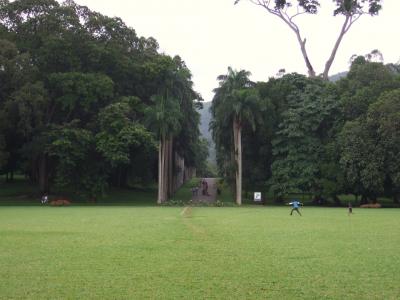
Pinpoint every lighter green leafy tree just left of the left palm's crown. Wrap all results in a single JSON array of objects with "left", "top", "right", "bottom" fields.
[{"left": 96, "top": 97, "right": 157, "bottom": 187}]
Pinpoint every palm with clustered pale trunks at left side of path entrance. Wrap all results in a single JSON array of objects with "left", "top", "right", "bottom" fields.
[{"left": 148, "top": 57, "right": 199, "bottom": 203}]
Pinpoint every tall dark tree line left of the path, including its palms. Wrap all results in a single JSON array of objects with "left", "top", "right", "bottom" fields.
[{"left": 0, "top": 0, "right": 207, "bottom": 202}]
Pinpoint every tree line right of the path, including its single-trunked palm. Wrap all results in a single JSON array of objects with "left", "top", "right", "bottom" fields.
[{"left": 211, "top": 56, "right": 400, "bottom": 204}]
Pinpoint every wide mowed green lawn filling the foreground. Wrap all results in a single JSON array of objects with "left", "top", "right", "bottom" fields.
[{"left": 0, "top": 206, "right": 400, "bottom": 299}]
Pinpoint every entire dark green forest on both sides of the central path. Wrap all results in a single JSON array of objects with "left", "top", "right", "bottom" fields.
[{"left": 0, "top": 0, "right": 400, "bottom": 204}]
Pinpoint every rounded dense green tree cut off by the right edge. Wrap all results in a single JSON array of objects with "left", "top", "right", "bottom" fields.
[{"left": 339, "top": 89, "right": 400, "bottom": 202}]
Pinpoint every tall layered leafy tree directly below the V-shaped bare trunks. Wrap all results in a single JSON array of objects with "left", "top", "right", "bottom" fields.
[{"left": 271, "top": 76, "right": 339, "bottom": 196}]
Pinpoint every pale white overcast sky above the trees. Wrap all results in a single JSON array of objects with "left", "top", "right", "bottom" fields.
[{"left": 76, "top": 0, "right": 400, "bottom": 101}]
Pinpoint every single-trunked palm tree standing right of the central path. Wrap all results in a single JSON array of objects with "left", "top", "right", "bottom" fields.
[{"left": 211, "top": 67, "right": 260, "bottom": 205}]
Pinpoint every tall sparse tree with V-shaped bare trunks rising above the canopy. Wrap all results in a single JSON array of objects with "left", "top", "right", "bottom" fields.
[{"left": 235, "top": 0, "right": 382, "bottom": 80}]
